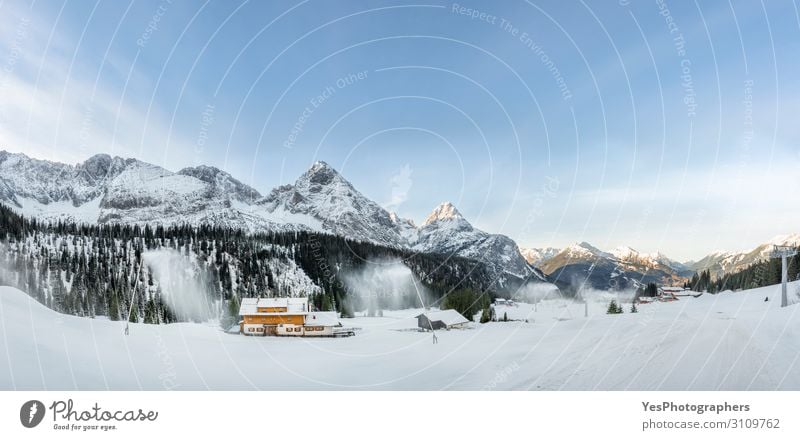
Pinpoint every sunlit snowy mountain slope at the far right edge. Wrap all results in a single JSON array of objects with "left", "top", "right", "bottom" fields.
[{"left": 686, "top": 234, "right": 800, "bottom": 277}]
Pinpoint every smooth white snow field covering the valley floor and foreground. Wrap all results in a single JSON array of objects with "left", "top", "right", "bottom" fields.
[{"left": 0, "top": 283, "right": 800, "bottom": 390}]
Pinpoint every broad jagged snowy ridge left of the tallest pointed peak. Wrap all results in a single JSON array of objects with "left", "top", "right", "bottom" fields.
[{"left": 0, "top": 151, "right": 293, "bottom": 231}]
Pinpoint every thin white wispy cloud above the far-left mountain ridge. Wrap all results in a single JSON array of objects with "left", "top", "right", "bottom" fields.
[{"left": 0, "top": 0, "right": 191, "bottom": 168}]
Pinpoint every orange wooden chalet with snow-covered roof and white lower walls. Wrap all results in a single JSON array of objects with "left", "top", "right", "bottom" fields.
[{"left": 234, "top": 298, "right": 341, "bottom": 336}]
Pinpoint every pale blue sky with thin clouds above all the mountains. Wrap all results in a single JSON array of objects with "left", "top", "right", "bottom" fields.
[{"left": 0, "top": 0, "right": 800, "bottom": 259}]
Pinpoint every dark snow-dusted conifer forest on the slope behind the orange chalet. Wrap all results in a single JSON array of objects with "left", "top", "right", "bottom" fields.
[{"left": 0, "top": 205, "right": 524, "bottom": 325}]
